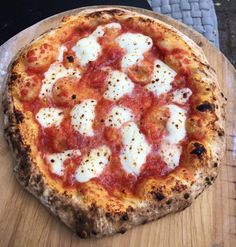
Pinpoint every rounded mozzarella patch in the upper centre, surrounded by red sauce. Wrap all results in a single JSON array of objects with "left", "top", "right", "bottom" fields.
[{"left": 103, "top": 70, "right": 134, "bottom": 101}]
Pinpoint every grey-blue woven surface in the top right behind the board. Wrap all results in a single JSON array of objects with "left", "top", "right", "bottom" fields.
[{"left": 148, "top": 0, "right": 219, "bottom": 47}]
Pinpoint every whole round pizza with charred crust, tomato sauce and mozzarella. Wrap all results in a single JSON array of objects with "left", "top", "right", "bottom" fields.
[{"left": 3, "top": 8, "right": 225, "bottom": 238}]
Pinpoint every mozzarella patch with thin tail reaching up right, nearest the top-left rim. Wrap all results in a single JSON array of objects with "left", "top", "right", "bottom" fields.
[{"left": 72, "top": 23, "right": 121, "bottom": 66}]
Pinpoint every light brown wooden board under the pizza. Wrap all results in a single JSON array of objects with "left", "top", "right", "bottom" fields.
[{"left": 0, "top": 7, "right": 236, "bottom": 247}]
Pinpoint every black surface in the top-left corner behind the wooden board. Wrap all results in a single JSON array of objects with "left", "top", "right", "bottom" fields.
[{"left": 0, "top": 0, "right": 151, "bottom": 45}]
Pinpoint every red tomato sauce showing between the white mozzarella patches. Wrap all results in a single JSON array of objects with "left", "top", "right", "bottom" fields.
[{"left": 22, "top": 19, "right": 194, "bottom": 194}]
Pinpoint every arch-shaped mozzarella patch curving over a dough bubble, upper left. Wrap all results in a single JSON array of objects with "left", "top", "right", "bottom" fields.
[{"left": 39, "top": 62, "right": 81, "bottom": 97}]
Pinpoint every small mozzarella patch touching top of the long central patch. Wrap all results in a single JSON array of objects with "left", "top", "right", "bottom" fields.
[{"left": 105, "top": 106, "right": 134, "bottom": 128}]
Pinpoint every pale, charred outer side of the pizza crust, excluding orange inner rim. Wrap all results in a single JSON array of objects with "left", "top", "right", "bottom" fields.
[{"left": 3, "top": 8, "right": 225, "bottom": 238}]
